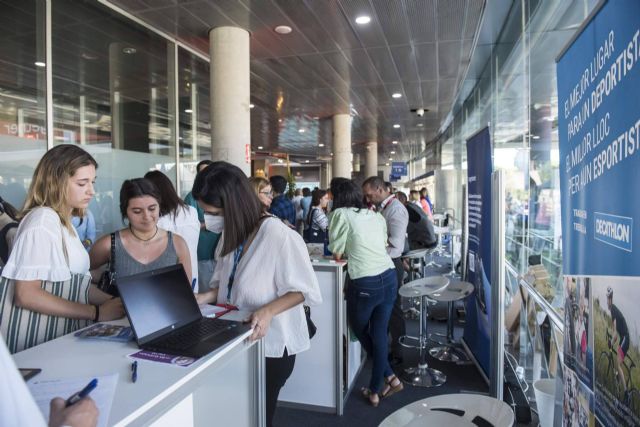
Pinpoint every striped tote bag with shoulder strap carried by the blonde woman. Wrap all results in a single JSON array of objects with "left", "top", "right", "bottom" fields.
[{"left": 0, "top": 221, "right": 93, "bottom": 354}]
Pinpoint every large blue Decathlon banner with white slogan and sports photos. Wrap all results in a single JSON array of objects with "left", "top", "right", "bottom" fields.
[{"left": 557, "top": 0, "right": 640, "bottom": 426}]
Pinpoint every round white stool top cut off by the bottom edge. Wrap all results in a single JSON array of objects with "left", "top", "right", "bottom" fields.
[{"left": 379, "top": 393, "right": 515, "bottom": 427}]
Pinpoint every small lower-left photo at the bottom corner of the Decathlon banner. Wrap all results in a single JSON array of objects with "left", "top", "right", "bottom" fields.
[{"left": 562, "top": 366, "right": 595, "bottom": 427}]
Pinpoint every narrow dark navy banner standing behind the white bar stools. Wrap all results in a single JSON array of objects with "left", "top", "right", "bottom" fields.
[{"left": 464, "top": 127, "right": 493, "bottom": 377}]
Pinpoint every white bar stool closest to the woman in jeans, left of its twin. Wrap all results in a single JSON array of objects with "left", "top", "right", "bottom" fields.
[{"left": 398, "top": 276, "right": 449, "bottom": 387}]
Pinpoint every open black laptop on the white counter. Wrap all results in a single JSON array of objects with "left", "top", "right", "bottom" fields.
[{"left": 117, "top": 264, "right": 251, "bottom": 357}]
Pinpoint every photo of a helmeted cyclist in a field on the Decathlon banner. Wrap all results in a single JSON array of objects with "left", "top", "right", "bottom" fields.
[{"left": 591, "top": 276, "right": 640, "bottom": 426}]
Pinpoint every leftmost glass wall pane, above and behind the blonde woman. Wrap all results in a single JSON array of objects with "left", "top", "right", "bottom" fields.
[{"left": 0, "top": 0, "right": 47, "bottom": 208}]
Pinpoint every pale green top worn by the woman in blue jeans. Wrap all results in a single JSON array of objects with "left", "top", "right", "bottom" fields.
[{"left": 329, "top": 208, "right": 394, "bottom": 279}]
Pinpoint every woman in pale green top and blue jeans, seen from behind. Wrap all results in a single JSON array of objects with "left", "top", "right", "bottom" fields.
[{"left": 329, "top": 179, "right": 403, "bottom": 407}]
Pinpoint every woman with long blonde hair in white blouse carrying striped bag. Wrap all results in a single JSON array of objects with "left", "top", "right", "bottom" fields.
[{"left": 0, "top": 144, "right": 124, "bottom": 352}]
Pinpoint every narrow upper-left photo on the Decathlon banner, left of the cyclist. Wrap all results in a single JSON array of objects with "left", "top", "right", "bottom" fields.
[{"left": 564, "top": 276, "right": 593, "bottom": 389}]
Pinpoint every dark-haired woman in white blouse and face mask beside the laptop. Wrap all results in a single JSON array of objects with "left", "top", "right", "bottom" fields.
[{"left": 193, "top": 162, "right": 322, "bottom": 426}]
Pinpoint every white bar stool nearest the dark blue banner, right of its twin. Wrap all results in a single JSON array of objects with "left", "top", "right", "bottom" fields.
[{"left": 429, "top": 280, "right": 473, "bottom": 363}]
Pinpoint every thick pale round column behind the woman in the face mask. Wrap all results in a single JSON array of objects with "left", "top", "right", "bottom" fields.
[{"left": 209, "top": 27, "right": 251, "bottom": 175}]
